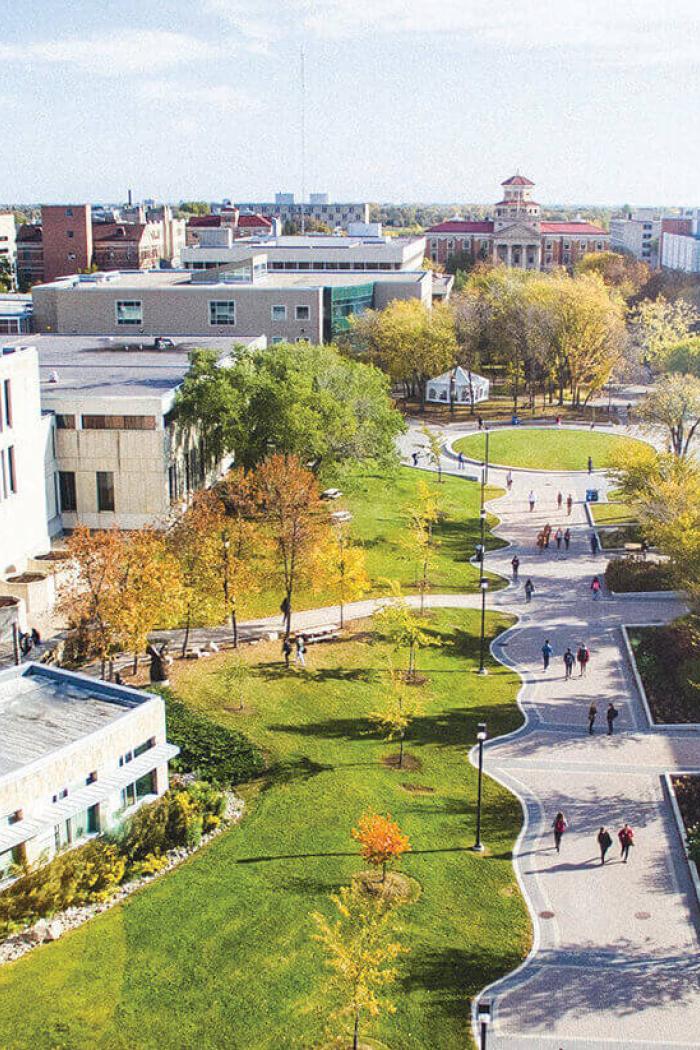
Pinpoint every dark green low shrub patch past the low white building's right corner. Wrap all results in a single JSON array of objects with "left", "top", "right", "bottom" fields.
[{"left": 160, "top": 690, "right": 264, "bottom": 788}]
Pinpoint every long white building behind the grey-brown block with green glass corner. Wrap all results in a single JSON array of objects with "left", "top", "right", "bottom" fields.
[{"left": 181, "top": 223, "right": 425, "bottom": 273}]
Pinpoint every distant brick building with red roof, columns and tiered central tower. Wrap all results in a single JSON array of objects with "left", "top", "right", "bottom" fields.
[{"left": 426, "top": 174, "right": 609, "bottom": 270}]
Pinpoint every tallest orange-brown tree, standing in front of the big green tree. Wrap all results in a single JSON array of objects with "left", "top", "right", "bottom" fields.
[{"left": 254, "top": 455, "right": 331, "bottom": 637}]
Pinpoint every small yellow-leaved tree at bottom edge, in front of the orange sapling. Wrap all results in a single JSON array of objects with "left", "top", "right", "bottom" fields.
[{"left": 313, "top": 886, "right": 408, "bottom": 1050}]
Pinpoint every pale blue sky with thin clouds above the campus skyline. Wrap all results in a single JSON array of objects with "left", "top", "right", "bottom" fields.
[{"left": 0, "top": 0, "right": 700, "bottom": 206}]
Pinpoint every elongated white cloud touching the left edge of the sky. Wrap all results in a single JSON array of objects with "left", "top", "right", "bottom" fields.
[{"left": 0, "top": 28, "right": 224, "bottom": 77}]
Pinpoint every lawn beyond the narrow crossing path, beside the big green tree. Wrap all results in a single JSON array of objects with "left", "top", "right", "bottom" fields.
[{"left": 241, "top": 467, "right": 503, "bottom": 618}]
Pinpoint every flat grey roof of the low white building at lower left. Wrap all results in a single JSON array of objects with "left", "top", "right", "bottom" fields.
[{"left": 0, "top": 664, "right": 151, "bottom": 777}]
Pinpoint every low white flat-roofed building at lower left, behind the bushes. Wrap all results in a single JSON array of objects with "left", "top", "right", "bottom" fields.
[{"left": 0, "top": 664, "right": 178, "bottom": 883}]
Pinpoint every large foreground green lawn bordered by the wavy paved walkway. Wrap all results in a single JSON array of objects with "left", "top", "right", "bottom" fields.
[{"left": 0, "top": 610, "right": 530, "bottom": 1050}]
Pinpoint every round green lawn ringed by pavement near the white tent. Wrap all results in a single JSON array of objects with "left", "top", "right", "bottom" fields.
[{"left": 454, "top": 426, "right": 642, "bottom": 470}]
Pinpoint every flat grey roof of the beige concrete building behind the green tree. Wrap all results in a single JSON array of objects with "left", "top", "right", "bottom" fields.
[{"left": 0, "top": 332, "right": 260, "bottom": 398}]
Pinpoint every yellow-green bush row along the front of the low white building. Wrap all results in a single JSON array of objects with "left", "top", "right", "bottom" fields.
[{"left": 0, "top": 781, "right": 226, "bottom": 937}]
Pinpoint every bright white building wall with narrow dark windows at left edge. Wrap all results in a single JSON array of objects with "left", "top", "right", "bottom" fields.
[{"left": 0, "top": 347, "right": 49, "bottom": 575}]
